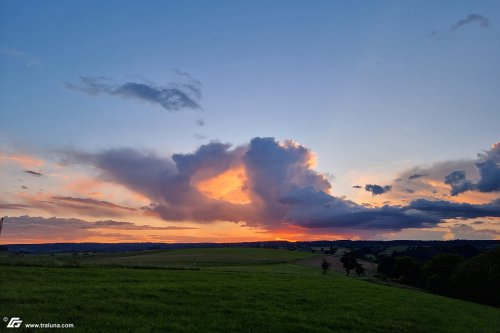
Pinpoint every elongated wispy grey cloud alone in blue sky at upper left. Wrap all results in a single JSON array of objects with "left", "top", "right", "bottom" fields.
[{"left": 64, "top": 77, "right": 201, "bottom": 111}]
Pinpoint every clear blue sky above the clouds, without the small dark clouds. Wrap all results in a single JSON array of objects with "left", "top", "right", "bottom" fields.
[{"left": 0, "top": 1, "right": 500, "bottom": 240}]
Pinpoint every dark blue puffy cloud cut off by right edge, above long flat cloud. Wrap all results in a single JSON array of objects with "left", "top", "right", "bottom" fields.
[{"left": 444, "top": 142, "right": 500, "bottom": 195}]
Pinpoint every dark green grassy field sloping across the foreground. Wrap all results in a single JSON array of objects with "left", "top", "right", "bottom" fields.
[{"left": 0, "top": 248, "right": 500, "bottom": 333}]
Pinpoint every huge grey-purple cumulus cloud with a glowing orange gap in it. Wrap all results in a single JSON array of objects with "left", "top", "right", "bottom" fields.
[{"left": 64, "top": 138, "right": 500, "bottom": 230}]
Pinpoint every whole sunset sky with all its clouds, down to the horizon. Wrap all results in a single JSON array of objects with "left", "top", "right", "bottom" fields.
[{"left": 0, "top": 0, "right": 500, "bottom": 244}]
